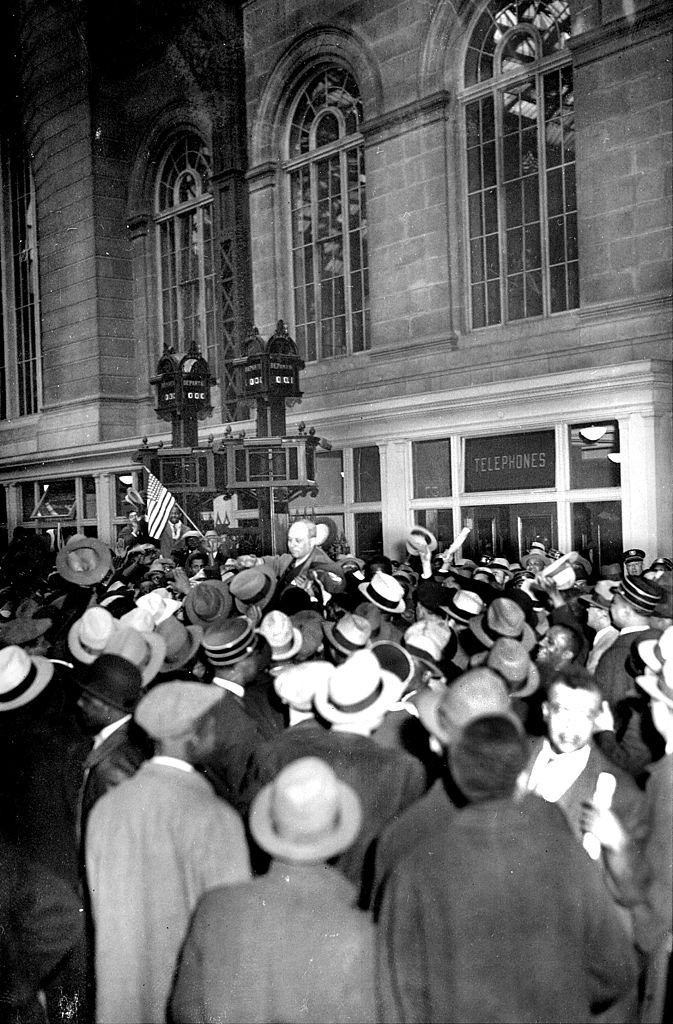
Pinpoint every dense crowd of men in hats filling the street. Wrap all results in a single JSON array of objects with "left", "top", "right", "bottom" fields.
[{"left": 0, "top": 511, "right": 673, "bottom": 1024}]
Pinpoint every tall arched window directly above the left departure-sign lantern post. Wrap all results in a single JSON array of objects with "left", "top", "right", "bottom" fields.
[{"left": 155, "top": 133, "right": 217, "bottom": 373}]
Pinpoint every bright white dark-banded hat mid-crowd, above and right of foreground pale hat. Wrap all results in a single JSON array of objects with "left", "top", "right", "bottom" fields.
[{"left": 314, "top": 650, "right": 402, "bottom": 725}]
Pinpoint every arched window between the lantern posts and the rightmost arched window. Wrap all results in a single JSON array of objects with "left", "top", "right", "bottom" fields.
[{"left": 287, "top": 67, "right": 369, "bottom": 361}]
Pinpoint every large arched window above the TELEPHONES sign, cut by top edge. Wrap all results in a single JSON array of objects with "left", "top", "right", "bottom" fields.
[{"left": 463, "top": 0, "right": 579, "bottom": 328}]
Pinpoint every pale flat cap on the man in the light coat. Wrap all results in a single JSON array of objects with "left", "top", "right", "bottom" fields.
[{"left": 133, "top": 680, "right": 224, "bottom": 739}]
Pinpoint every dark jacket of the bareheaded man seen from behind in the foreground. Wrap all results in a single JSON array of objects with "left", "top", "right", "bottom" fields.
[{"left": 377, "top": 794, "right": 635, "bottom": 1024}]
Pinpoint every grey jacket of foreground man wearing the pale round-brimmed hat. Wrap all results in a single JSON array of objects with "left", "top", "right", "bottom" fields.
[{"left": 171, "top": 862, "right": 377, "bottom": 1024}]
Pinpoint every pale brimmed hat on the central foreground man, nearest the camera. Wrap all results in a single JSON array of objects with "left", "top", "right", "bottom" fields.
[{"left": 250, "top": 758, "right": 362, "bottom": 863}]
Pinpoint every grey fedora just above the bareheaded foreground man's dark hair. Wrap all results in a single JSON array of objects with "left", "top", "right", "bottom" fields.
[{"left": 416, "top": 668, "right": 512, "bottom": 746}]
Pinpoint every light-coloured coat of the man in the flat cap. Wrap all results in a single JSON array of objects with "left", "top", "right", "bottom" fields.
[{"left": 86, "top": 761, "right": 250, "bottom": 1024}]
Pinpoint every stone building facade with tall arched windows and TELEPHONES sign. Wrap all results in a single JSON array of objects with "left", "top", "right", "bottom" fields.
[{"left": 0, "top": 0, "right": 673, "bottom": 571}]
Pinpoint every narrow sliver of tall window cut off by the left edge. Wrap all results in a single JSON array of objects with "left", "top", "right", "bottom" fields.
[{"left": 0, "top": 133, "right": 41, "bottom": 420}]
